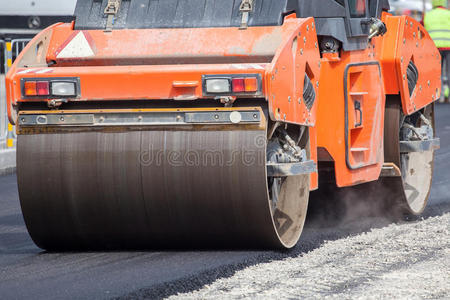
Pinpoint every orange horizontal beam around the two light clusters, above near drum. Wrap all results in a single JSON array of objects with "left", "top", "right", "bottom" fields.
[{"left": 8, "top": 64, "right": 264, "bottom": 102}]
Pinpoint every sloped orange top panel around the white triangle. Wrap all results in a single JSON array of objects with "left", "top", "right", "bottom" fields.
[{"left": 47, "top": 24, "right": 278, "bottom": 66}]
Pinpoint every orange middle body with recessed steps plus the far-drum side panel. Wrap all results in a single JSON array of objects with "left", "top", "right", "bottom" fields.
[{"left": 316, "top": 14, "right": 440, "bottom": 187}]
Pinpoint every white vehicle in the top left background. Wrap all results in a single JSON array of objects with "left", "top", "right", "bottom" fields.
[{"left": 0, "top": 0, "right": 77, "bottom": 38}]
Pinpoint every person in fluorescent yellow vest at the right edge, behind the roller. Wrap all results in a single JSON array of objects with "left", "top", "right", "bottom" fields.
[{"left": 424, "top": 0, "right": 450, "bottom": 102}]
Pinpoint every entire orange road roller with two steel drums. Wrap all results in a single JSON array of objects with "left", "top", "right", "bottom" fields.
[{"left": 6, "top": 0, "right": 441, "bottom": 250}]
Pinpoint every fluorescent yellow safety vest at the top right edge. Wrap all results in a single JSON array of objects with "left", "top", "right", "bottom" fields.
[{"left": 424, "top": 7, "right": 450, "bottom": 48}]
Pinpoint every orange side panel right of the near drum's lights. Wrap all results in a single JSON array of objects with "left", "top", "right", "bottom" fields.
[{"left": 266, "top": 18, "right": 320, "bottom": 126}]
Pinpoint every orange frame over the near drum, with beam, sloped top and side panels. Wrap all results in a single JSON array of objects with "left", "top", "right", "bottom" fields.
[{"left": 6, "top": 15, "right": 320, "bottom": 189}]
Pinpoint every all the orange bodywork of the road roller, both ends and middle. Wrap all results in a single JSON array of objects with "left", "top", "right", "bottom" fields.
[{"left": 6, "top": 14, "right": 439, "bottom": 189}]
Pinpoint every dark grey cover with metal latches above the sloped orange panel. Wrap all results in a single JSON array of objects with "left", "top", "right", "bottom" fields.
[{"left": 75, "top": 0, "right": 297, "bottom": 30}]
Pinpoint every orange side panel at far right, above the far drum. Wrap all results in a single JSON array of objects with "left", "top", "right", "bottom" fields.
[{"left": 376, "top": 14, "right": 441, "bottom": 115}]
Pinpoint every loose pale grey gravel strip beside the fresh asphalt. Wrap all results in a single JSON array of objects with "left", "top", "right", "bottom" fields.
[{"left": 169, "top": 213, "right": 450, "bottom": 299}]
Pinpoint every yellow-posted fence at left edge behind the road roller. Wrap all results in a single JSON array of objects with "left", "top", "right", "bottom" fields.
[{"left": 0, "top": 39, "right": 30, "bottom": 149}]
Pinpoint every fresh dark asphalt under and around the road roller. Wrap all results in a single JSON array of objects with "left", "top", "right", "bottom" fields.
[{"left": 0, "top": 105, "right": 450, "bottom": 299}]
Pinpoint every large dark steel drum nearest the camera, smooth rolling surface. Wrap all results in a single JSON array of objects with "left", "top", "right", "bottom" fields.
[{"left": 17, "top": 127, "right": 309, "bottom": 249}]
